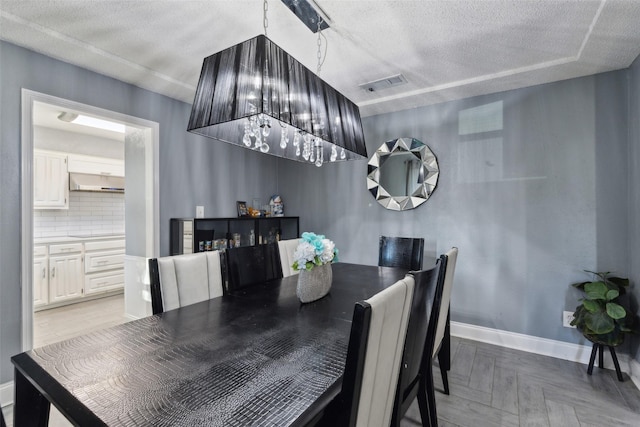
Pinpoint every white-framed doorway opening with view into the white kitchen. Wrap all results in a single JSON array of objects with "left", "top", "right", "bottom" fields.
[{"left": 22, "top": 89, "right": 159, "bottom": 351}]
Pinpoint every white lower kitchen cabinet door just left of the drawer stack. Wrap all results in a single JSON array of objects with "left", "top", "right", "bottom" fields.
[{"left": 49, "top": 243, "right": 84, "bottom": 304}]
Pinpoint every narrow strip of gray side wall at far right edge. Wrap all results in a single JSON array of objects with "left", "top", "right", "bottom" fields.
[{"left": 628, "top": 57, "right": 640, "bottom": 362}]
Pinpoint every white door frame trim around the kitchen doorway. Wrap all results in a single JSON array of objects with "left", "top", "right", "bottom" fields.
[{"left": 21, "top": 88, "right": 160, "bottom": 351}]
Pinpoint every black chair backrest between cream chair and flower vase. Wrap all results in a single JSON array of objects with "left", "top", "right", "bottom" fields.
[{"left": 225, "top": 243, "right": 282, "bottom": 292}]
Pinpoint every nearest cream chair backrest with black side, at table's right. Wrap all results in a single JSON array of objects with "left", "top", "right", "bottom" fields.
[{"left": 339, "top": 276, "right": 414, "bottom": 427}]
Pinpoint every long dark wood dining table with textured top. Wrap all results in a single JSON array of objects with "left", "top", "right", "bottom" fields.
[{"left": 11, "top": 263, "right": 407, "bottom": 427}]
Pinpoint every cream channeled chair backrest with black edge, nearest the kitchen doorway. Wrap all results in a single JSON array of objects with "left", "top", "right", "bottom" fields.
[{"left": 149, "top": 251, "right": 223, "bottom": 314}]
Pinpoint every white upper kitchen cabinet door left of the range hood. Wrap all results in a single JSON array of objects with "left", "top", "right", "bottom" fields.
[{"left": 33, "top": 150, "right": 69, "bottom": 209}]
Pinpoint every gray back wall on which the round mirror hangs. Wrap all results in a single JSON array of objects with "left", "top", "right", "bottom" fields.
[{"left": 280, "top": 71, "right": 629, "bottom": 350}]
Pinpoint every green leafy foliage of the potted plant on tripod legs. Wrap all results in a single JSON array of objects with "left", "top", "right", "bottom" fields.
[{"left": 571, "top": 270, "right": 637, "bottom": 347}]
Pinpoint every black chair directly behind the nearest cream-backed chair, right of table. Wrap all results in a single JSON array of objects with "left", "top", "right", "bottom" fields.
[{"left": 391, "top": 262, "right": 447, "bottom": 427}]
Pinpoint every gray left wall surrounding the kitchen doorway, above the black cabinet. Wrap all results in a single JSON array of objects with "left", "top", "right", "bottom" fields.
[{"left": 0, "top": 42, "right": 278, "bottom": 384}]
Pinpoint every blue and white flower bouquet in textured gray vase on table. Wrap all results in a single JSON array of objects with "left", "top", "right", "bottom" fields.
[{"left": 292, "top": 232, "right": 338, "bottom": 303}]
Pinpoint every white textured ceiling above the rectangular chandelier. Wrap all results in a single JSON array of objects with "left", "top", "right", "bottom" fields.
[{"left": 0, "top": 0, "right": 640, "bottom": 116}]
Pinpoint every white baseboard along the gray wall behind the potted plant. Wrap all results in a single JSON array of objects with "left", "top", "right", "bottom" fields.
[{"left": 451, "top": 322, "right": 640, "bottom": 376}]
